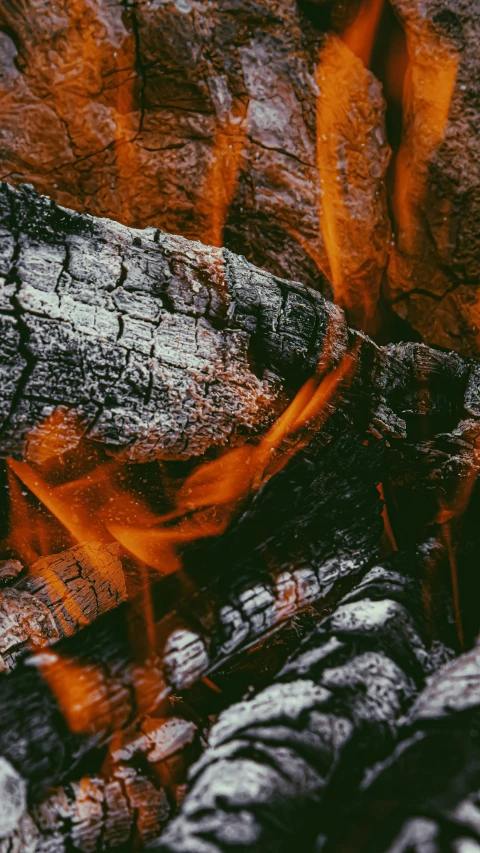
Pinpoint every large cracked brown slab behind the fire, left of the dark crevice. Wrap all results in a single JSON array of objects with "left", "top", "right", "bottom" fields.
[{"left": 0, "top": 0, "right": 396, "bottom": 321}]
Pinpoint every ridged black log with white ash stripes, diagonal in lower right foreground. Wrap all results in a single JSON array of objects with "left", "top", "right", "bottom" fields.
[{"left": 154, "top": 546, "right": 458, "bottom": 853}]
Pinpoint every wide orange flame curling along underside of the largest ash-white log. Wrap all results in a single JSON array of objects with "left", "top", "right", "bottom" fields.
[{"left": 2, "top": 348, "right": 356, "bottom": 580}]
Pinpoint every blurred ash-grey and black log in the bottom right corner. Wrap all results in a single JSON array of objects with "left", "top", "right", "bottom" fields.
[{"left": 319, "top": 646, "right": 480, "bottom": 853}]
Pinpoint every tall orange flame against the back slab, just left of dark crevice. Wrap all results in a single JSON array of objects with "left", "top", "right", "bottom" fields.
[{"left": 316, "top": 35, "right": 390, "bottom": 333}]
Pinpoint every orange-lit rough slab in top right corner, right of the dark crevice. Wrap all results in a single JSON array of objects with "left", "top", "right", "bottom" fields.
[{"left": 388, "top": 0, "right": 480, "bottom": 358}]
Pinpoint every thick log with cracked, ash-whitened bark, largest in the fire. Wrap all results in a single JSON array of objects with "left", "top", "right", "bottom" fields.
[{"left": 0, "top": 178, "right": 346, "bottom": 461}]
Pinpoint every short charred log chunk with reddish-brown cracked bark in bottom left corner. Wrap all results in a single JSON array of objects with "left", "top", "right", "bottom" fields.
[{"left": 0, "top": 717, "right": 201, "bottom": 853}]
